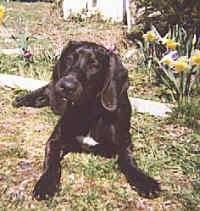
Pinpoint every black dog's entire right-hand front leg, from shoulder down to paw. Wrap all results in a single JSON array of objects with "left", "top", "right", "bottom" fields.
[{"left": 115, "top": 95, "right": 161, "bottom": 198}]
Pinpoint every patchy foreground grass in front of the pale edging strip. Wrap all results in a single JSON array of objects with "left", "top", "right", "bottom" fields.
[{"left": 0, "top": 89, "right": 200, "bottom": 210}]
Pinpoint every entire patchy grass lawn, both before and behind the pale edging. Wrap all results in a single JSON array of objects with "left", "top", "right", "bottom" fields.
[{"left": 0, "top": 2, "right": 200, "bottom": 211}]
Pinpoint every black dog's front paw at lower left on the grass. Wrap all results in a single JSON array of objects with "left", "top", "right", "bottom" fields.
[{"left": 33, "top": 174, "right": 59, "bottom": 200}]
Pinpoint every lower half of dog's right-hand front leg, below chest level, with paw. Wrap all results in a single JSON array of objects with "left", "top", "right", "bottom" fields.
[{"left": 118, "top": 138, "right": 161, "bottom": 198}]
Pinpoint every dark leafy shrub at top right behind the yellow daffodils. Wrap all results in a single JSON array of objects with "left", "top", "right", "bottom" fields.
[{"left": 130, "top": 0, "right": 200, "bottom": 39}]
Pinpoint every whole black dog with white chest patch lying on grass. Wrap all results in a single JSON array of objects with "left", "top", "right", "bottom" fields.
[{"left": 14, "top": 41, "right": 160, "bottom": 199}]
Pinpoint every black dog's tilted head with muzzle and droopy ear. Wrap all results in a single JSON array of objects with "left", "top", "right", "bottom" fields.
[{"left": 50, "top": 42, "right": 128, "bottom": 111}]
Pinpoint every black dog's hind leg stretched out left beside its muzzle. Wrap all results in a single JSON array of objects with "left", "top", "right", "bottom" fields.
[{"left": 12, "top": 85, "right": 49, "bottom": 108}]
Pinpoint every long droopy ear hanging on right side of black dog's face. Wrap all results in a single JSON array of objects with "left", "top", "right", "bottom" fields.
[{"left": 101, "top": 55, "right": 118, "bottom": 112}]
